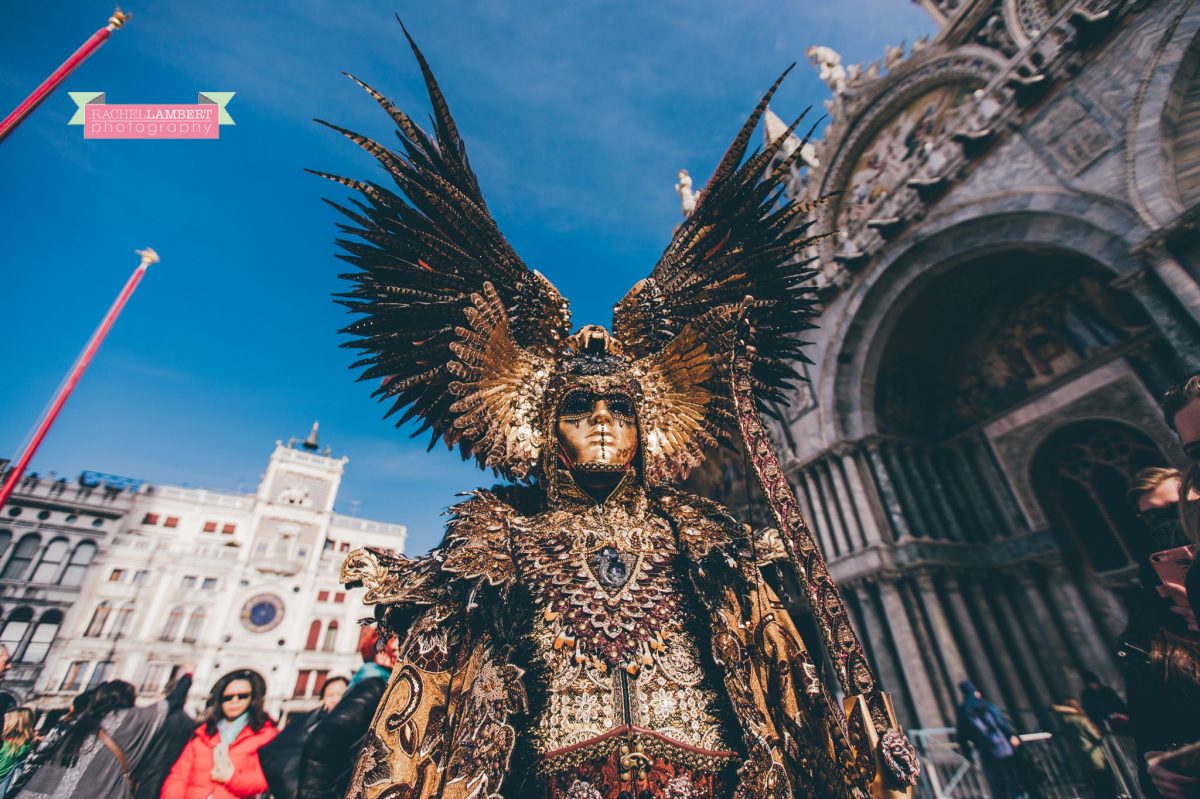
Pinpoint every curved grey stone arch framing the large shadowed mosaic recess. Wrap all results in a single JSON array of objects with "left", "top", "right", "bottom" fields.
[{"left": 818, "top": 199, "right": 1140, "bottom": 440}]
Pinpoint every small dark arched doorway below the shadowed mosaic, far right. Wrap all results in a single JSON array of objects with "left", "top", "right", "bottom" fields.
[{"left": 1032, "top": 420, "right": 1169, "bottom": 575}]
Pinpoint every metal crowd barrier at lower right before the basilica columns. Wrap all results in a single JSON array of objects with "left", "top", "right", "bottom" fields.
[{"left": 908, "top": 727, "right": 1144, "bottom": 799}]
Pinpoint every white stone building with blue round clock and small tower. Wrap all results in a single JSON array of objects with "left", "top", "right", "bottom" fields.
[{"left": 37, "top": 427, "right": 407, "bottom": 715}]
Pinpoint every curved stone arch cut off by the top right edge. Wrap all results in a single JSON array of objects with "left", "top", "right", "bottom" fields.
[{"left": 1126, "top": 4, "right": 1200, "bottom": 228}]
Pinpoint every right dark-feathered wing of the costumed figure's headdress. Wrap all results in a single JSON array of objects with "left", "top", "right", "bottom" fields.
[{"left": 613, "top": 67, "right": 828, "bottom": 475}]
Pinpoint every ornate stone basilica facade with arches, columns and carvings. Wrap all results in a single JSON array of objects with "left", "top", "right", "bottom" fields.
[{"left": 695, "top": 0, "right": 1200, "bottom": 728}]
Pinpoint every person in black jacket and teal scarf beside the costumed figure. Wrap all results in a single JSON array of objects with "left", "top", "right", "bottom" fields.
[{"left": 295, "top": 636, "right": 400, "bottom": 799}]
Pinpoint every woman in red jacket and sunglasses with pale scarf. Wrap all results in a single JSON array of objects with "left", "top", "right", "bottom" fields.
[{"left": 161, "top": 671, "right": 278, "bottom": 799}]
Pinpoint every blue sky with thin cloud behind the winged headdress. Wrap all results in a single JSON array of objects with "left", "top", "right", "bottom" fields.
[{"left": 0, "top": 0, "right": 932, "bottom": 552}]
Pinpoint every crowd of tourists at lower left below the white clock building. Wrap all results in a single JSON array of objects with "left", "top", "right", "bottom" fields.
[{"left": 0, "top": 630, "right": 397, "bottom": 799}]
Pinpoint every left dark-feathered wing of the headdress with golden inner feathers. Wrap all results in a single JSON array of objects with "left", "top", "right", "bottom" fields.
[{"left": 314, "top": 25, "right": 570, "bottom": 479}]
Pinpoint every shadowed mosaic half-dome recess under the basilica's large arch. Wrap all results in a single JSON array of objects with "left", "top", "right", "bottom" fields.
[{"left": 875, "top": 250, "right": 1150, "bottom": 443}]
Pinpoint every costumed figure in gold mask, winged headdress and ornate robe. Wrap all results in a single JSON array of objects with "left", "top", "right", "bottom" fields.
[{"left": 309, "top": 24, "right": 918, "bottom": 799}]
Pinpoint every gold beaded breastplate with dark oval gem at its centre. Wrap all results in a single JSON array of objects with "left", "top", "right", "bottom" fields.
[{"left": 514, "top": 489, "right": 736, "bottom": 779}]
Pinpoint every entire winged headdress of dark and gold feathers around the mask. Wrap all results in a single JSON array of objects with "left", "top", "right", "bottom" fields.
[{"left": 316, "top": 21, "right": 820, "bottom": 483}]
